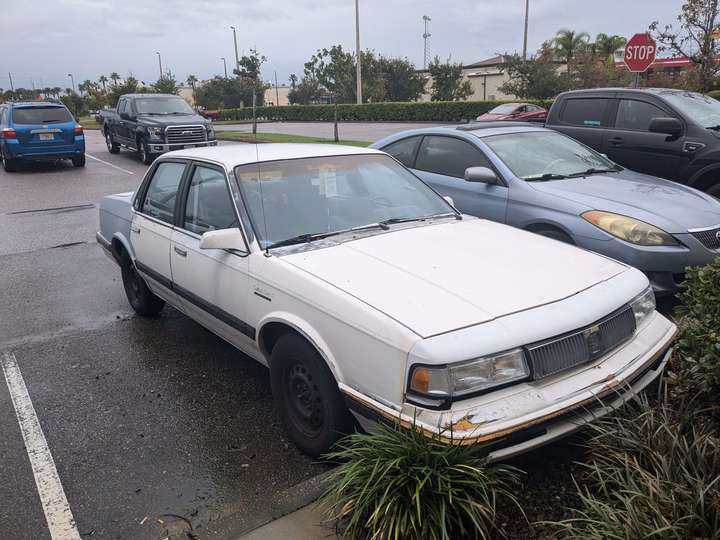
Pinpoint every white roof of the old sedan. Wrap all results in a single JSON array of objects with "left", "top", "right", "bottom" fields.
[{"left": 163, "top": 143, "right": 383, "bottom": 169}]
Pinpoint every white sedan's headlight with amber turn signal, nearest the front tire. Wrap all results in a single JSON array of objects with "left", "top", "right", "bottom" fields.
[{"left": 408, "top": 349, "right": 530, "bottom": 402}]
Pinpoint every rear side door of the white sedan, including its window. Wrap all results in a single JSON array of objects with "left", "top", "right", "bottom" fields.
[{"left": 130, "top": 160, "right": 187, "bottom": 302}]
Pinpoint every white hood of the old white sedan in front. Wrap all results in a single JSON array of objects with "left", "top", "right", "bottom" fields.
[{"left": 282, "top": 217, "right": 627, "bottom": 337}]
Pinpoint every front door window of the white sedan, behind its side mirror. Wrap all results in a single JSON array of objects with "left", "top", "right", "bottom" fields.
[{"left": 183, "top": 166, "right": 238, "bottom": 234}]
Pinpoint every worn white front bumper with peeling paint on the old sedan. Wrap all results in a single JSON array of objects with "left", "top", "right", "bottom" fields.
[{"left": 340, "top": 313, "right": 677, "bottom": 460}]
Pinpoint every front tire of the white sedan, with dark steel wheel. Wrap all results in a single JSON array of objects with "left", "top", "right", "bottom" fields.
[{"left": 270, "top": 334, "right": 354, "bottom": 458}]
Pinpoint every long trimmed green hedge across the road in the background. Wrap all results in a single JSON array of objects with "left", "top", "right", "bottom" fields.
[{"left": 219, "top": 101, "right": 552, "bottom": 122}]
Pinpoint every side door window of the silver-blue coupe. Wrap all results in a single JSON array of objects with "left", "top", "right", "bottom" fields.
[{"left": 415, "top": 136, "right": 490, "bottom": 178}]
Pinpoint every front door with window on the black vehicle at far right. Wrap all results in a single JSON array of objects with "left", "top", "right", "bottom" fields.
[{"left": 603, "top": 95, "right": 691, "bottom": 180}]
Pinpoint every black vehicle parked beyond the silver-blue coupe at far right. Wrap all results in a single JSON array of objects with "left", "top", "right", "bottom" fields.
[{"left": 545, "top": 88, "right": 720, "bottom": 198}]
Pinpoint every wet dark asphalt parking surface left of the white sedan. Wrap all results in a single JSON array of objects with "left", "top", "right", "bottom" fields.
[{"left": 0, "top": 131, "right": 326, "bottom": 540}]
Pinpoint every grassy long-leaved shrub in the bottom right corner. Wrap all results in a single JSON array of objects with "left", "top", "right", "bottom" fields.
[{"left": 555, "top": 403, "right": 720, "bottom": 540}]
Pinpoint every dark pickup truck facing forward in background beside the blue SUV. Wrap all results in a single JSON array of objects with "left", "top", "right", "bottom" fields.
[{"left": 100, "top": 94, "right": 217, "bottom": 165}]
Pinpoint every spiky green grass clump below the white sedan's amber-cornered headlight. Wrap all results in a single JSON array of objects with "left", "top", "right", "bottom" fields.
[{"left": 320, "top": 425, "right": 519, "bottom": 540}]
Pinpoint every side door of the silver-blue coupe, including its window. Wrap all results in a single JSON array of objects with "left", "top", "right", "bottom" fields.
[{"left": 414, "top": 135, "right": 508, "bottom": 223}]
